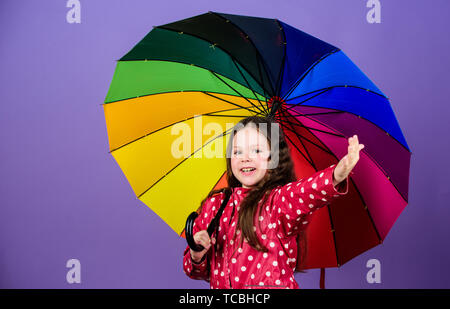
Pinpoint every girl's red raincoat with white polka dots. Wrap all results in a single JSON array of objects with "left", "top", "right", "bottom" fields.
[{"left": 183, "top": 164, "right": 348, "bottom": 289}]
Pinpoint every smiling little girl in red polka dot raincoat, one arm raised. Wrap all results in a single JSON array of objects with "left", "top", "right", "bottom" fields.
[{"left": 183, "top": 116, "right": 364, "bottom": 289}]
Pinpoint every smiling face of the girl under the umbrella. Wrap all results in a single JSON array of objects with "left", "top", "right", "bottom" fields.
[{"left": 231, "top": 126, "right": 270, "bottom": 188}]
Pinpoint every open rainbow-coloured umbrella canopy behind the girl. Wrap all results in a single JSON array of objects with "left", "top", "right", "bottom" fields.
[{"left": 103, "top": 12, "right": 411, "bottom": 269}]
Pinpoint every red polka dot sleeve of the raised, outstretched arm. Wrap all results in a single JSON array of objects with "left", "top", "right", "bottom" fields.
[{"left": 273, "top": 164, "right": 348, "bottom": 236}]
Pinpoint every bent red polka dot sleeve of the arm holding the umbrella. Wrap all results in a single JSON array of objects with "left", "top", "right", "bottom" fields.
[{"left": 183, "top": 195, "right": 221, "bottom": 282}]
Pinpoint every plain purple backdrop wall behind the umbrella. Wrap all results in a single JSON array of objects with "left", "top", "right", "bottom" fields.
[{"left": 0, "top": 0, "right": 450, "bottom": 289}]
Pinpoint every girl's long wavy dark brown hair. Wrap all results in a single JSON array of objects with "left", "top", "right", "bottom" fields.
[{"left": 199, "top": 116, "right": 306, "bottom": 265}]
